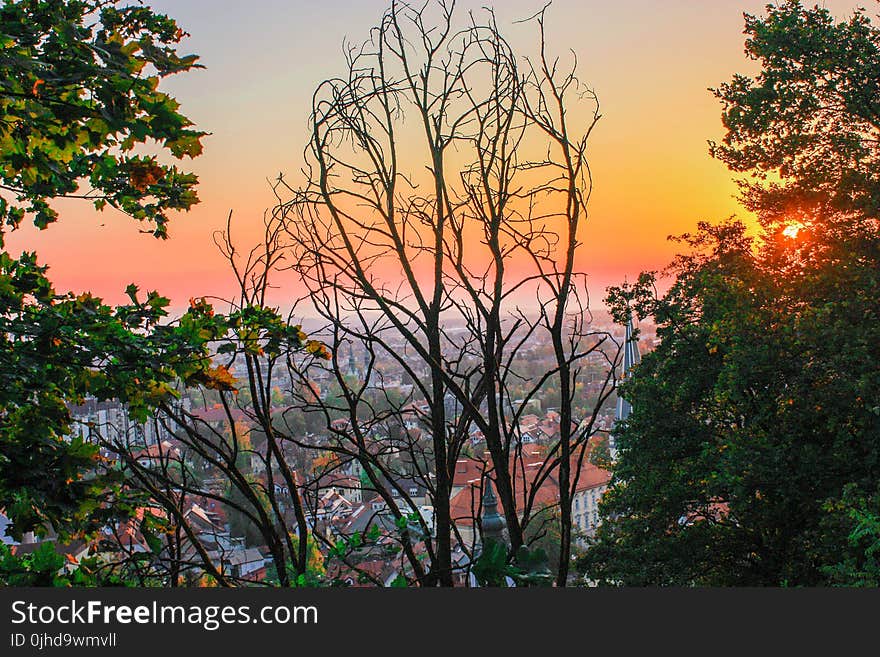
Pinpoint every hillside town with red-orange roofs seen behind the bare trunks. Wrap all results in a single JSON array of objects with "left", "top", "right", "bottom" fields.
[{"left": 0, "top": 316, "right": 653, "bottom": 586}]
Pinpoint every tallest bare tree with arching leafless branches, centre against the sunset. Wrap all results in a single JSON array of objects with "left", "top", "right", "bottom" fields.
[{"left": 275, "top": 1, "right": 617, "bottom": 586}]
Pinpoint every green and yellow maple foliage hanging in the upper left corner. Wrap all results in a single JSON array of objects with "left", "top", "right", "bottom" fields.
[{"left": 0, "top": 0, "right": 205, "bottom": 237}]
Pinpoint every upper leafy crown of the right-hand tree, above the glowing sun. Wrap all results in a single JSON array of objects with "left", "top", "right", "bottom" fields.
[{"left": 711, "top": 0, "right": 880, "bottom": 223}]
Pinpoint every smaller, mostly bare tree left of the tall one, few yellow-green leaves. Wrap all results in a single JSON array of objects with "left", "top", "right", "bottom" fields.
[{"left": 85, "top": 215, "right": 326, "bottom": 586}]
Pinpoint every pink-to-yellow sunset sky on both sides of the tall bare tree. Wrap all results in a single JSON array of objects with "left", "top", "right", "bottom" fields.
[{"left": 7, "top": 0, "right": 870, "bottom": 312}]
